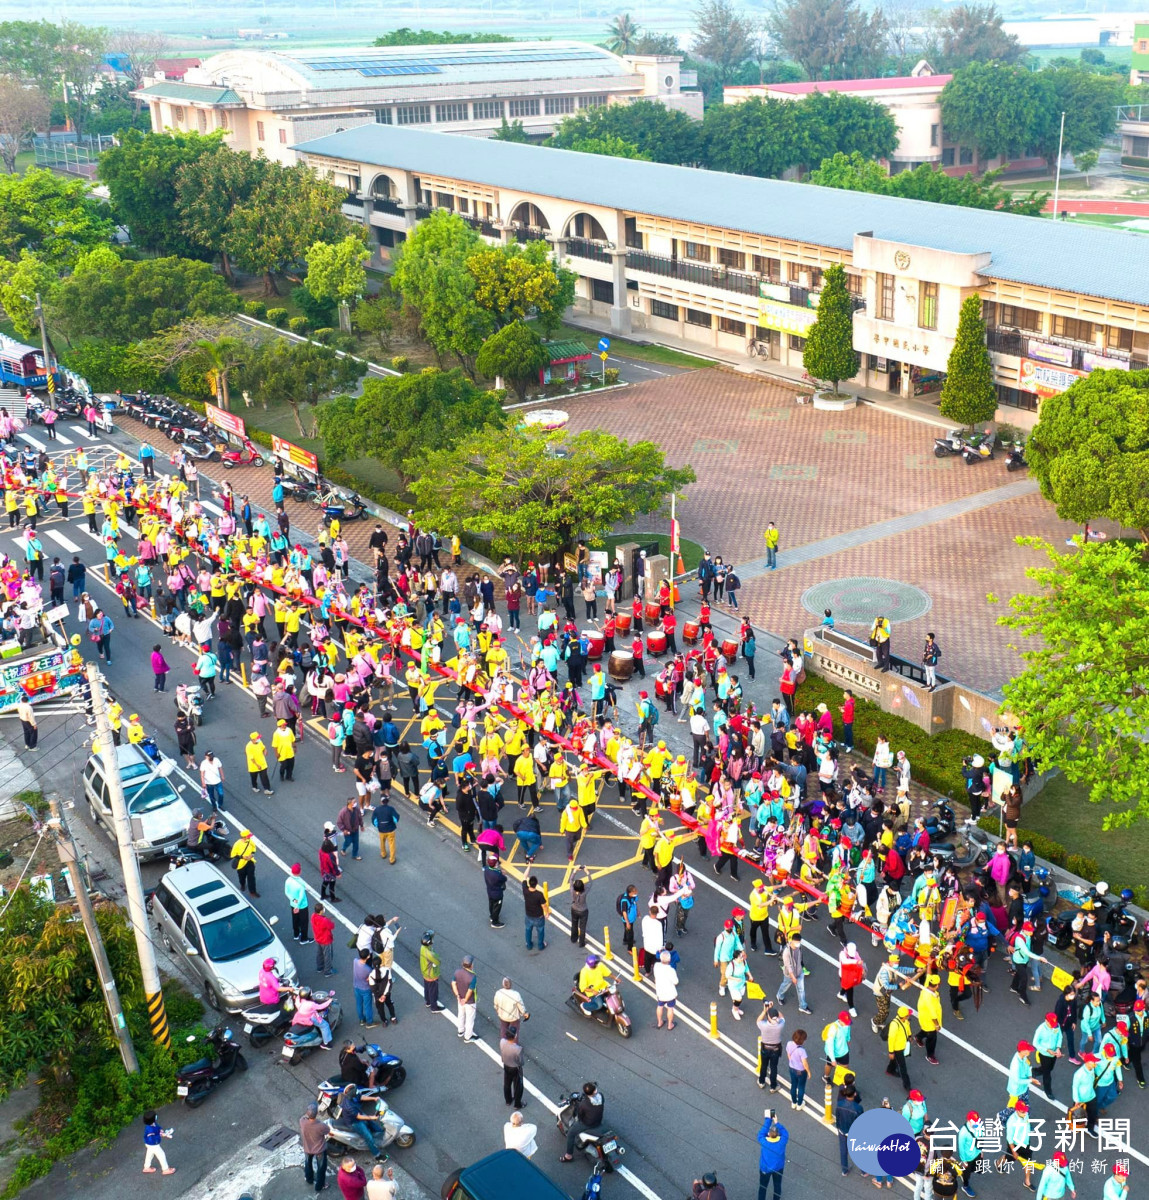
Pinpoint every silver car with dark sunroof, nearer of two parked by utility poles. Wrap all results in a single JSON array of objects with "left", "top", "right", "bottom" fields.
[{"left": 150, "top": 863, "right": 296, "bottom": 1013}]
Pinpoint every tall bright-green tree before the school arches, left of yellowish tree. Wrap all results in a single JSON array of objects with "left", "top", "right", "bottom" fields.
[{"left": 391, "top": 210, "right": 494, "bottom": 378}]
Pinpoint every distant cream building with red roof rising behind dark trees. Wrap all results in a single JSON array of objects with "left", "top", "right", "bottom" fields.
[{"left": 722, "top": 59, "right": 1045, "bottom": 175}]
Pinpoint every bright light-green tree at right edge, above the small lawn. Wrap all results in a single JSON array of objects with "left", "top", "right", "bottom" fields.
[{"left": 1000, "top": 542, "right": 1149, "bottom": 829}]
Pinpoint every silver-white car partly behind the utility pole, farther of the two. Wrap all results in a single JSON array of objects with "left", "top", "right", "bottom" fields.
[{"left": 84, "top": 745, "right": 192, "bottom": 859}]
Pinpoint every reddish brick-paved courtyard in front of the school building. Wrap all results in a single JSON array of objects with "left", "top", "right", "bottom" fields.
[{"left": 570, "top": 370, "right": 1079, "bottom": 691}]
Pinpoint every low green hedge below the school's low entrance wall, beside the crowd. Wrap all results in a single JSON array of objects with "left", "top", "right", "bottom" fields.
[{"left": 796, "top": 673, "right": 993, "bottom": 799}]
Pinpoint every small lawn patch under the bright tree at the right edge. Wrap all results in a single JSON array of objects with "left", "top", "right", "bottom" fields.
[{"left": 1021, "top": 775, "right": 1149, "bottom": 892}]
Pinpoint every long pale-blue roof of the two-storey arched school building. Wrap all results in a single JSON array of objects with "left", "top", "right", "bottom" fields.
[{"left": 295, "top": 125, "right": 1149, "bottom": 305}]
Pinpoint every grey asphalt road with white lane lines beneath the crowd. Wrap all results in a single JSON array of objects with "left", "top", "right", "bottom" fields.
[{"left": 0, "top": 412, "right": 1147, "bottom": 1200}]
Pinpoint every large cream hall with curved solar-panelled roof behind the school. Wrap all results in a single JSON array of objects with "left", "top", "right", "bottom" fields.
[{"left": 133, "top": 42, "right": 702, "bottom": 163}]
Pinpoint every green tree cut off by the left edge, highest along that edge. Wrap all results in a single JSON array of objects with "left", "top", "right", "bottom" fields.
[{"left": 0, "top": 167, "right": 113, "bottom": 270}]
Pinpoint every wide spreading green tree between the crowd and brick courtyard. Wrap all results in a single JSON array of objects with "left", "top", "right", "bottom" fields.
[{"left": 410, "top": 427, "right": 694, "bottom": 558}]
